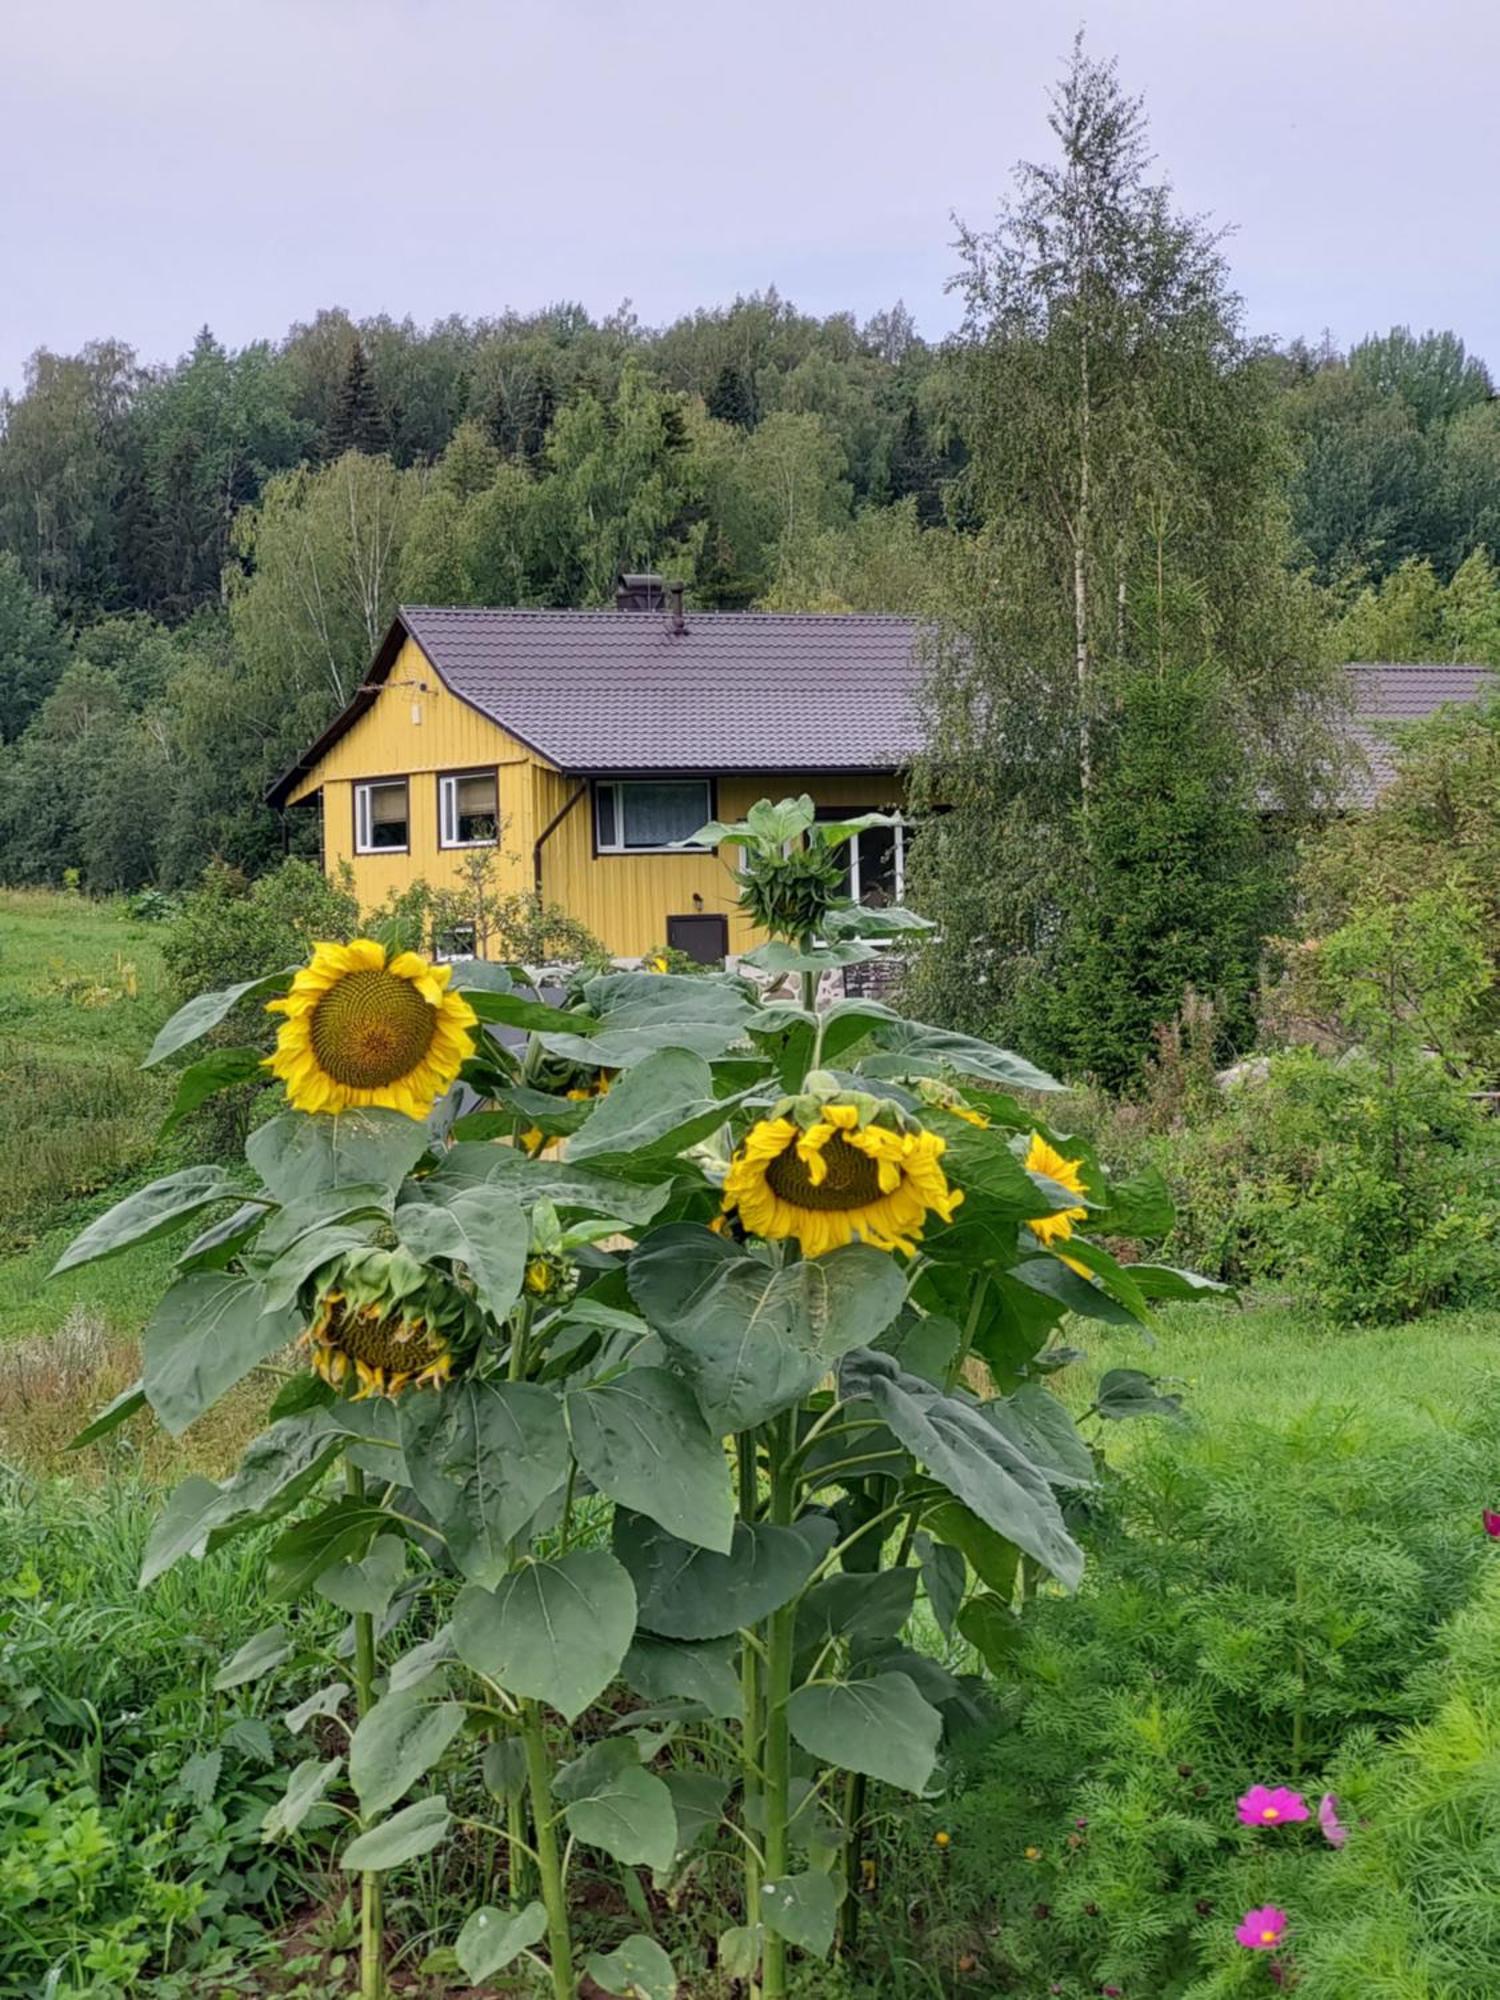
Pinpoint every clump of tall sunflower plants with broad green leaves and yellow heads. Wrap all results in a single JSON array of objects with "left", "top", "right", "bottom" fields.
[{"left": 58, "top": 798, "right": 1206, "bottom": 2000}]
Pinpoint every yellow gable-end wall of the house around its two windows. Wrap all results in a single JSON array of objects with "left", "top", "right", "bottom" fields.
[{"left": 292, "top": 638, "right": 536, "bottom": 908}]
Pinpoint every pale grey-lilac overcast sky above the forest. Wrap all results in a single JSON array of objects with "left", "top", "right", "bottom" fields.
[{"left": 0, "top": 0, "right": 1500, "bottom": 386}]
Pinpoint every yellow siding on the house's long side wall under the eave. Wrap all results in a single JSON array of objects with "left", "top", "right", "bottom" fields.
[{"left": 534, "top": 768, "right": 900, "bottom": 958}]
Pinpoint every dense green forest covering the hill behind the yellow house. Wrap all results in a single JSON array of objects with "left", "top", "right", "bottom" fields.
[{"left": 0, "top": 292, "right": 1500, "bottom": 890}]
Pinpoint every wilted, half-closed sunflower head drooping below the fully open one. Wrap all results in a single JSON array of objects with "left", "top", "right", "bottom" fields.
[{"left": 302, "top": 1250, "right": 480, "bottom": 1402}]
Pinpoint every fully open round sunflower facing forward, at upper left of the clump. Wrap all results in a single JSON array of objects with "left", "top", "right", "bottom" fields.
[{"left": 266, "top": 938, "right": 478, "bottom": 1118}]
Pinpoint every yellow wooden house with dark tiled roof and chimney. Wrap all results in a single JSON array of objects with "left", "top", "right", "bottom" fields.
[{"left": 270, "top": 576, "right": 918, "bottom": 962}]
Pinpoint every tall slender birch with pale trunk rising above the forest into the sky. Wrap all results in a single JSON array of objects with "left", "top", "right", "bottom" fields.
[{"left": 914, "top": 40, "right": 1330, "bottom": 1060}]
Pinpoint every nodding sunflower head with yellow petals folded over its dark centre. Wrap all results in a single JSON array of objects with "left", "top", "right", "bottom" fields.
[{"left": 724, "top": 1078, "right": 964, "bottom": 1256}]
